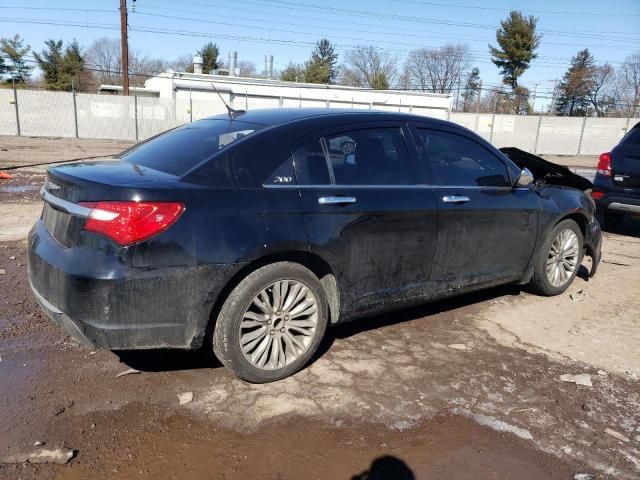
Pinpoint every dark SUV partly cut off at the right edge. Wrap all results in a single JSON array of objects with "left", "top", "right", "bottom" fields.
[{"left": 592, "top": 123, "right": 640, "bottom": 228}]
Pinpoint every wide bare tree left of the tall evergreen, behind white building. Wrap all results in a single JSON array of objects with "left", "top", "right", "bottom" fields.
[{"left": 406, "top": 44, "right": 469, "bottom": 93}]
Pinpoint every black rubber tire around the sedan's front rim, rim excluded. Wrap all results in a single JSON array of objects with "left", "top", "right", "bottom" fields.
[{"left": 529, "top": 219, "right": 584, "bottom": 297}]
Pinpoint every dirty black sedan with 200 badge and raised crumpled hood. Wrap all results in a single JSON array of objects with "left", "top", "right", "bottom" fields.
[{"left": 28, "top": 109, "right": 601, "bottom": 382}]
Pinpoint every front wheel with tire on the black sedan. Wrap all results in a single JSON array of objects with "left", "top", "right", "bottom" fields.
[{"left": 530, "top": 220, "right": 584, "bottom": 296}]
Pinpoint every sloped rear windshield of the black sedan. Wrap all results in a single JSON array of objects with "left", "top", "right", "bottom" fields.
[{"left": 122, "top": 120, "right": 264, "bottom": 176}]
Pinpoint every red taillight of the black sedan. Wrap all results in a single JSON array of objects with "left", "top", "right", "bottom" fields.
[{"left": 80, "top": 202, "right": 184, "bottom": 246}]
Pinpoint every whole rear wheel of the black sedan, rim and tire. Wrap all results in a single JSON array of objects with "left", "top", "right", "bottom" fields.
[{"left": 213, "top": 262, "right": 327, "bottom": 383}]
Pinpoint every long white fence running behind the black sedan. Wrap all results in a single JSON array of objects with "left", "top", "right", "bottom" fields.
[{"left": 0, "top": 90, "right": 635, "bottom": 155}]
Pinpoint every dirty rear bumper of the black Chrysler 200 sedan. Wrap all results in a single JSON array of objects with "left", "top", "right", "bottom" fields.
[{"left": 28, "top": 221, "right": 239, "bottom": 350}]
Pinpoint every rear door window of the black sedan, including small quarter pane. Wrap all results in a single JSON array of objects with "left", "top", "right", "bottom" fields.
[{"left": 293, "top": 128, "right": 415, "bottom": 185}]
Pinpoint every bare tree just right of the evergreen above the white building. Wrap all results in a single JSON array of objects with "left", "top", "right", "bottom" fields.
[{"left": 341, "top": 46, "right": 397, "bottom": 90}]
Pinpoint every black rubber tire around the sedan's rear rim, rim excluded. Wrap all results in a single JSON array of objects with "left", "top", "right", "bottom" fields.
[{"left": 212, "top": 262, "right": 328, "bottom": 383}]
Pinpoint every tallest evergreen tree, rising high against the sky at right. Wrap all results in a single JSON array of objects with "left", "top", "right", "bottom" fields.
[{"left": 489, "top": 11, "right": 540, "bottom": 89}]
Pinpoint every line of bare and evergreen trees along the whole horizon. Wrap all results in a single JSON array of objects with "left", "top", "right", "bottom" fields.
[{"left": 0, "top": 11, "right": 640, "bottom": 116}]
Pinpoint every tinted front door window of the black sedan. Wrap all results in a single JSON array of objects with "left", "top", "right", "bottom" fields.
[{"left": 416, "top": 128, "right": 511, "bottom": 187}]
